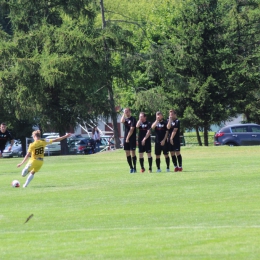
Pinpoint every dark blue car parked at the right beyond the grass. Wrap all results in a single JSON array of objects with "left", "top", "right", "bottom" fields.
[{"left": 214, "top": 124, "right": 260, "bottom": 146}]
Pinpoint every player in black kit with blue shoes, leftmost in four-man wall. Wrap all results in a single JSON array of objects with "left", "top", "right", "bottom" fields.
[{"left": 121, "top": 108, "right": 136, "bottom": 173}]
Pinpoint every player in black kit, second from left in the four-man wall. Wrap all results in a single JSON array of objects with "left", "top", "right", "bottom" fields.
[{"left": 136, "top": 112, "right": 153, "bottom": 172}]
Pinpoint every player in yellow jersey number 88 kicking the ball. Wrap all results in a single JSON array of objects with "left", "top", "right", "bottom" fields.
[{"left": 17, "top": 130, "right": 71, "bottom": 188}]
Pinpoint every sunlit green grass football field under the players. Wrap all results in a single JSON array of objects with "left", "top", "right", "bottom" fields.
[{"left": 0, "top": 147, "right": 260, "bottom": 260}]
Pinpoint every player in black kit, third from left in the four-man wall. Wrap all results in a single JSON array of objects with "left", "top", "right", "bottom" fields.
[{"left": 152, "top": 111, "right": 170, "bottom": 172}]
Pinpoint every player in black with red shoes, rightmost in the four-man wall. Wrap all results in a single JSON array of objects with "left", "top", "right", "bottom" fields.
[{"left": 167, "top": 110, "right": 182, "bottom": 172}]
